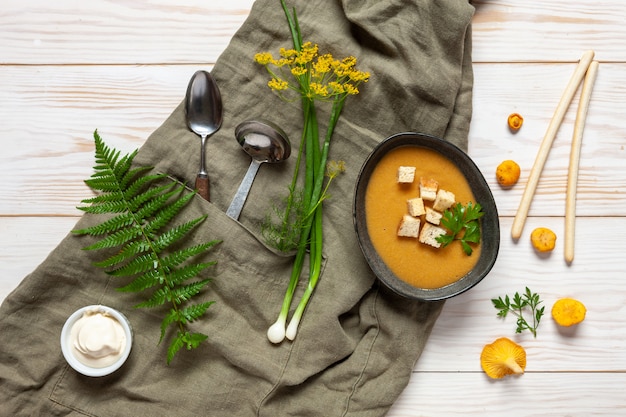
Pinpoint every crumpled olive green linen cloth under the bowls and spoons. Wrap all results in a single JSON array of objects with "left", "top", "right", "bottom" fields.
[{"left": 0, "top": 0, "right": 474, "bottom": 417}]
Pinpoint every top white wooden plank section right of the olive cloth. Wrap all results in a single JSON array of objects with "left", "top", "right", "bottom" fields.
[{"left": 472, "top": 0, "right": 626, "bottom": 62}]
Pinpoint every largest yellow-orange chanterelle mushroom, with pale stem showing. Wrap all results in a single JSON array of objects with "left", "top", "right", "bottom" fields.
[{"left": 480, "top": 337, "right": 526, "bottom": 379}]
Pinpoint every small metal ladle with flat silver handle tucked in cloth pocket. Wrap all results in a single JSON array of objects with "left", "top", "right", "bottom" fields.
[{"left": 226, "top": 120, "right": 291, "bottom": 220}]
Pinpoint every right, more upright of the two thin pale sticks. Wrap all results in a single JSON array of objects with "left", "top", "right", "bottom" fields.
[{"left": 565, "top": 61, "right": 599, "bottom": 263}]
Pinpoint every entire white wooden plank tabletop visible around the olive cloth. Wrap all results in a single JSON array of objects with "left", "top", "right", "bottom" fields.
[{"left": 0, "top": 0, "right": 626, "bottom": 417}]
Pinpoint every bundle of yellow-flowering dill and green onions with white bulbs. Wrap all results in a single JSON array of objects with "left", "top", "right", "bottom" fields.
[{"left": 254, "top": 0, "right": 370, "bottom": 343}]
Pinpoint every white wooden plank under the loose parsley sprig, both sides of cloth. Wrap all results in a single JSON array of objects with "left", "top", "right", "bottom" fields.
[{"left": 0, "top": 217, "right": 626, "bottom": 372}]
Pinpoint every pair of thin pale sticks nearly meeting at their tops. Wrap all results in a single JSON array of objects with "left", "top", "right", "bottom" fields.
[{"left": 511, "top": 51, "right": 598, "bottom": 263}]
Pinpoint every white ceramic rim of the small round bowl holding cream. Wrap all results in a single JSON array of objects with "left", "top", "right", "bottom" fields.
[{"left": 61, "top": 305, "right": 133, "bottom": 377}]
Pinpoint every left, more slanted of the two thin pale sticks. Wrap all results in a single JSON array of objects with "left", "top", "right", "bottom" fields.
[{"left": 511, "top": 51, "right": 595, "bottom": 239}]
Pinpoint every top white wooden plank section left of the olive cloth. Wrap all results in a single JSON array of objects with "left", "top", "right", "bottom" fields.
[{"left": 0, "top": 0, "right": 254, "bottom": 65}]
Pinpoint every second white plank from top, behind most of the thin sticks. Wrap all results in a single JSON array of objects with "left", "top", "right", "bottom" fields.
[{"left": 0, "top": 64, "right": 626, "bottom": 216}]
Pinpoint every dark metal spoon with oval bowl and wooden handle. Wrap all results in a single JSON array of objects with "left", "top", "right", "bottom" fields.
[{"left": 185, "top": 70, "right": 222, "bottom": 201}]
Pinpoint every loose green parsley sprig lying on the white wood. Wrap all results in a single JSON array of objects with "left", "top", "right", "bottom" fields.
[{"left": 491, "top": 287, "right": 545, "bottom": 337}]
